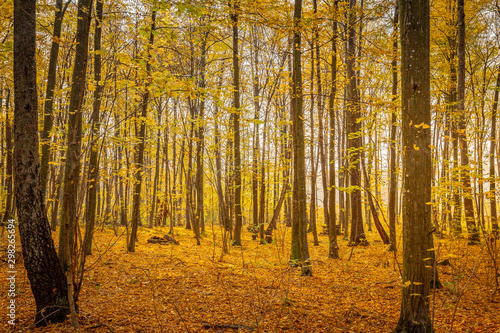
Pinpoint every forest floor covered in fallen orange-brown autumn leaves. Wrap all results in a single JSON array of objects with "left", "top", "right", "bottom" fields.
[{"left": 0, "top": 222, "right": 500, "bottom": 333}]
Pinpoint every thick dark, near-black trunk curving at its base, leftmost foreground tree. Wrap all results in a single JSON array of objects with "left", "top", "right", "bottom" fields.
[{"left": 14, "top": 0, "right": 69, "bottom": 326}]
